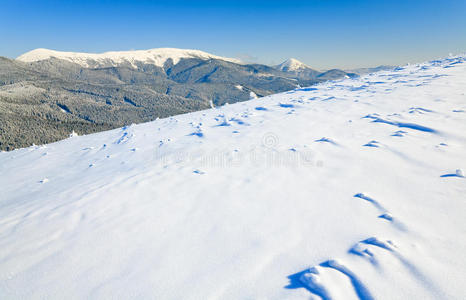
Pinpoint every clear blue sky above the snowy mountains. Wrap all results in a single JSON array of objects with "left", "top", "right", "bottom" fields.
[{"left": 0, "top": 0, "right": 466, "bottom": 69}]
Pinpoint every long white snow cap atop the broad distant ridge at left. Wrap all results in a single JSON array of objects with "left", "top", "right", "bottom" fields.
[{"left": 16, "top": 48, "right": 241, "bottom": 67}]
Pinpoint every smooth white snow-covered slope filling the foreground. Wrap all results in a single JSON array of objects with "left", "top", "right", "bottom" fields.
[{"left": 0, "top": 57, "right": 466, "bottom": 300}]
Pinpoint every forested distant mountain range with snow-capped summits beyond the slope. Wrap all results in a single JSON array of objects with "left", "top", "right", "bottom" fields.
[{"left": 0, "top": 48, "right": 357, "bottom": 150}]
